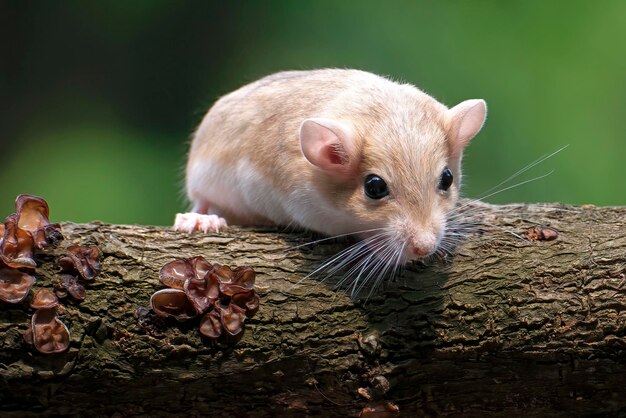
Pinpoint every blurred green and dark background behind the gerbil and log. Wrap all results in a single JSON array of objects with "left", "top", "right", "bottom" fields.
[{"left": 0, "top": 0, "right": 626, "bottom": 225}]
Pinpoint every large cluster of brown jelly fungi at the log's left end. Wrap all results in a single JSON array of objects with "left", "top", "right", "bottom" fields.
[{"left": 0, "top": 194, "right": 100, "bottom": 354}]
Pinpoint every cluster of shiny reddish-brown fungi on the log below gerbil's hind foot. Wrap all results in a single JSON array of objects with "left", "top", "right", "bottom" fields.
[{"left": 150, "top": 257, "right": 259, "bottom": 340}]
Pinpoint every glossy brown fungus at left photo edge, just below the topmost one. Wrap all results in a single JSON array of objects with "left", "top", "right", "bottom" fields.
[{"left": 0, "top": 213, "right": 37, "bottom": 268}]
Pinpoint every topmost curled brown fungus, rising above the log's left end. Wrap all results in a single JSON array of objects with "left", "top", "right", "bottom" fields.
[{"left": 15, "top": 194, "right": 63, "bottom": 248}]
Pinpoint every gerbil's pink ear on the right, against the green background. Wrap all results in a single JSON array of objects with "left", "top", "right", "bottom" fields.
[{"left": 448, "top": 99, "right": 487, "bottom": 153}]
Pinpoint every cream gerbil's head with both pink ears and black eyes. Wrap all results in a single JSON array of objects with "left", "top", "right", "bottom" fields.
[{"left": 300, "top": 93, "right": 487, "bottom": 265}]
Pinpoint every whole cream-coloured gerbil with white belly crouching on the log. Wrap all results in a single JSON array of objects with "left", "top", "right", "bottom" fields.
[{"left": 175, "top": 69, "right": 487, "bottom": 263}]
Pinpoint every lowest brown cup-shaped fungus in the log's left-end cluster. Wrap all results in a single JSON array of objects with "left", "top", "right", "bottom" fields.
[{"left": 31, "top": 308, "right": 70, "bottom": 354}]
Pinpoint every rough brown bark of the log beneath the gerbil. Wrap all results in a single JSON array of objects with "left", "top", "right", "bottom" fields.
[{"left": 0, "top": 205, "right": 626, "bottom": 417}]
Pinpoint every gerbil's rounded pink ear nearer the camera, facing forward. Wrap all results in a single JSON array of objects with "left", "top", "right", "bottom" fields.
[{"left": 300, "top": 118, "right": 358, "bottom": 177}]
